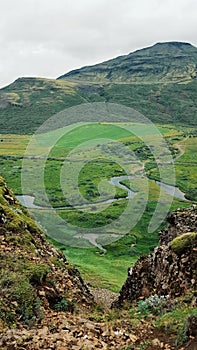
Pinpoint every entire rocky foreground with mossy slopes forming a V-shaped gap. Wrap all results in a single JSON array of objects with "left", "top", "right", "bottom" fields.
[{"left": 0, "top": 179, "right": 197, "bottom": 350}]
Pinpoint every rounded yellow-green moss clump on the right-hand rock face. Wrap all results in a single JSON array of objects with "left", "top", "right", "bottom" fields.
[{"left": 170, "top": 232, "right": 197, "bottom": 254}]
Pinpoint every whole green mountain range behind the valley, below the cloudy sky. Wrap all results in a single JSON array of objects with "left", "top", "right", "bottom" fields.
[{"left": 0, "top": 42, "right": 197, "bottom": 134}]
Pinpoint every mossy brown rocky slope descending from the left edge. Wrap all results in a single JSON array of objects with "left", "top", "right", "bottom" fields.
[{"left": 0, "top": 178, "right": 93, "bottom": 325}]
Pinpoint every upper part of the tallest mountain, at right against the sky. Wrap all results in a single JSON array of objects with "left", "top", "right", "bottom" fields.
[{"left": 59, "top": 42, "right": 197, "bottom": 84}]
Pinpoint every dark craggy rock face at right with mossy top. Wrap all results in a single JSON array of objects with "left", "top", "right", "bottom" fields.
[{"left": 116, "top": 207, "right": 197, "bottom": 306}]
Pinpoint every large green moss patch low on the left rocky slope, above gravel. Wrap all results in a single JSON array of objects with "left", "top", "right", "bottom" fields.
[{"left": 0, "top": 255, "right": 50, "bottom": 325}]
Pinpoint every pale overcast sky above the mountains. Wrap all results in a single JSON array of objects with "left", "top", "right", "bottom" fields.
[{"left": 0, "top": 0, "right": 197, "bottom": 87}]
